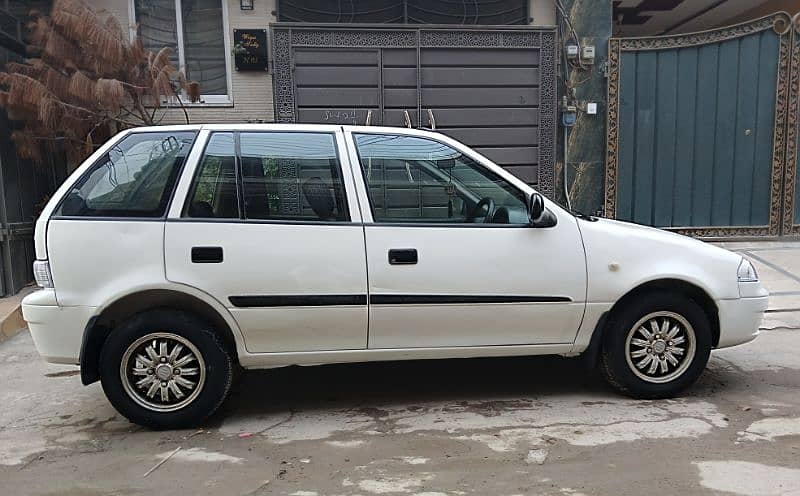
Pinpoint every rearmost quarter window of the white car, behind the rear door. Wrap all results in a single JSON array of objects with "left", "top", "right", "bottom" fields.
[{"left": 56, "top": 131, "right": 196, "bottom": 217}]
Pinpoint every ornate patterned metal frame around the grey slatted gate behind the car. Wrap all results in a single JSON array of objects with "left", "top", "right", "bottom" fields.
[{"left": 272, "top": 24, "right": 557, "bottom": 196}]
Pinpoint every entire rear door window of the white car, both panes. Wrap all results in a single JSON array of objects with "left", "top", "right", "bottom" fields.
[{"left": 185, "top": 132, "right": 350, "bottom": 222}]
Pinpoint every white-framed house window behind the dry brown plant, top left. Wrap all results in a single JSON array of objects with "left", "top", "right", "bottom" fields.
[{"left": 130, "top": 0, "right": 229, "bottom": 103}]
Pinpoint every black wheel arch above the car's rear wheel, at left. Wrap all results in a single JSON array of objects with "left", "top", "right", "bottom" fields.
[{"left": 80, "top": 288, "right": 241, "bottom": 385}]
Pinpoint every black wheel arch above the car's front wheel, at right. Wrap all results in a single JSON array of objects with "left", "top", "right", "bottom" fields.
[{"left": 584, "top": 277, "right": 720, "bottom": 367}]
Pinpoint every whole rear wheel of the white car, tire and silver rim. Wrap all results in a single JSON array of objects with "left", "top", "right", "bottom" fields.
[{"left": 100, "top": 309, "right": 233, "bottom": 429}]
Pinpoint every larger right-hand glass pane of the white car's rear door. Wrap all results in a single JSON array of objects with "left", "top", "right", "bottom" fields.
[{"left": 240, "top": 132, "right": 350, "bottom": 222}]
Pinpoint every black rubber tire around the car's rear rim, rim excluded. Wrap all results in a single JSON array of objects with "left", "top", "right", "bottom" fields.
[{"left": 100, "top": 309, "right": 233, "bottom": 429}]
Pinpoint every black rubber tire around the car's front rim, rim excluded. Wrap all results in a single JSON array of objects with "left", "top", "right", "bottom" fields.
[{"left": 602, "top": 293, "right": 712, "bottom": 399}]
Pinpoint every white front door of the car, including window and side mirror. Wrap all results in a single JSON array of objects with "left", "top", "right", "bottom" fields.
[{"left": 347, "top": 128, "right": 586, "bottom": 348}]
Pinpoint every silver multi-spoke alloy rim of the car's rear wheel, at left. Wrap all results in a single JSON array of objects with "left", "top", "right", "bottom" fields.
[{"left": 119, "top": 332, "right": 206, "bottom": 412}]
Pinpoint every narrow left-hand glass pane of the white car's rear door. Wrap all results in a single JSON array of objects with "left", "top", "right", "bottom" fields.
[{"left": 186, "top": 133, "right": 239, "bottom": 219}]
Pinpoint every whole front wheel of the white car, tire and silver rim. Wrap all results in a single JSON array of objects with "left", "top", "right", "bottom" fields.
[{"left": 600, "top": 292, "right": 711, "bottom": 399}]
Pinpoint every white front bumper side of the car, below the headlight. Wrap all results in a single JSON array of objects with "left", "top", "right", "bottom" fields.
[{"left": 717, "top": 291, "right": 769, "bottom": 348}]
